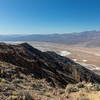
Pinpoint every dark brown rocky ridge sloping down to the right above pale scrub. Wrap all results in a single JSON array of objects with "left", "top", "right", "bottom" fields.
[{"left": 0, "top": 43, "right": 100, "bottom": 87}]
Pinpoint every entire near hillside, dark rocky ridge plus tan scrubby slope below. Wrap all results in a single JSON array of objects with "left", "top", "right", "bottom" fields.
[{"left": 0, "top": 43, "right": 100, "bottom": 100}]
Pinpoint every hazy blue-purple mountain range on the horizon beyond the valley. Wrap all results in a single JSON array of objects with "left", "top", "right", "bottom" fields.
[{"left": 0, "top": 31, "right": 100, "bottom": 47}]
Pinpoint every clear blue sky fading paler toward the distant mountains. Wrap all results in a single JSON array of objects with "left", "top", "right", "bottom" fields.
[{"left": 0, "top": 0, "right": 100, "bottom": 34}]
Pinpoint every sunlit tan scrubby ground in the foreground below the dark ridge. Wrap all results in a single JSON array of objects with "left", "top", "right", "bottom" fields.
[{"left": 0, "top": 61, "right": 100, "bottom": 100}]
